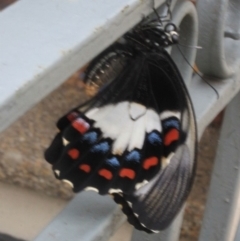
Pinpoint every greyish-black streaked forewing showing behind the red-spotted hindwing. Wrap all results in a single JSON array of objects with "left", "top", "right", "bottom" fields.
[{"left": 114, "top": 50, "right": 197, "bottom": 232}]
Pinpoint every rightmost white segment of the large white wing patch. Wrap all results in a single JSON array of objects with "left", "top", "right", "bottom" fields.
[{"left": 145, "top": 109, "right": 162, "bottom": 133}]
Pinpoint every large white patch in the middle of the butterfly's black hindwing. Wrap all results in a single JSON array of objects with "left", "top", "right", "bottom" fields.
[{"left": 86, "top": 101, "right": 154, "bottom": 155}]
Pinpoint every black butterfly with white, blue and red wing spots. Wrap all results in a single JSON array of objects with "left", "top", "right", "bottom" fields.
[{"left": 45, "top": 6, "right": 197, "bottom": 233}]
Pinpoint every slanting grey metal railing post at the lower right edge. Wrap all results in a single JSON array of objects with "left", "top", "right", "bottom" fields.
[{"left": 199, "top": 93, "right": 240, "bottom": 241}]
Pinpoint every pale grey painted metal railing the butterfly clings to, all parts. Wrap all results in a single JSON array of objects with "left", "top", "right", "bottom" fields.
[{"left": 0, "top": 0, "right": 240, "bottom": 241}]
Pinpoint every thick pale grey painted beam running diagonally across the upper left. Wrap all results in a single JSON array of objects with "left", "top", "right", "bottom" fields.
[{"left": 0, "top": 0, "right": 163, "bottom": 132}]
